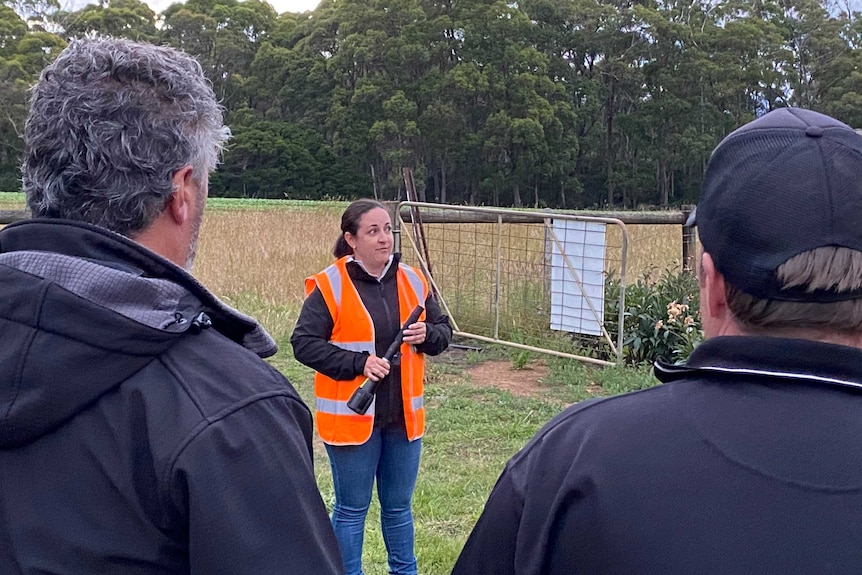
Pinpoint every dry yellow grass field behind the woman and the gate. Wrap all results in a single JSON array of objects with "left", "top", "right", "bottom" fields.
[{"left": 194, "top": 204, "right": 696, "bottom": 346}]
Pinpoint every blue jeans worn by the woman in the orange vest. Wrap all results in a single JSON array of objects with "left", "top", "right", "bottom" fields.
[{"left": 326, "top": 429, "right": 422, "bottom": 575}]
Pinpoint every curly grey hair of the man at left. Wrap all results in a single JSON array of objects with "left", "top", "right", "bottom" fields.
[{"left": 21, "top": 38, "right": 230, "bottom": 237}]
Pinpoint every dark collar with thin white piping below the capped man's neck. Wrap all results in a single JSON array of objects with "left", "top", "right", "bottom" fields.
[{"left": 654, "top": 336, "right": 862, "bottom": 389}]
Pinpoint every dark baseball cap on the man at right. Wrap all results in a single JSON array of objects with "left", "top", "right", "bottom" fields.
[{"left": 690, "top": 108, "right": 862, "bottom": 302}]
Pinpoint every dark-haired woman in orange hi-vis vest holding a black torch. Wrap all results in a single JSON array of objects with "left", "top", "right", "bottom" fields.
[{"left": 290, "top": 200, "right": 452, "bottom": 575}]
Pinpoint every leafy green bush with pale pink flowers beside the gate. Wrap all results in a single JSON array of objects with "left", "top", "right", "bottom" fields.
[{"left": 605, "top": 270, "right": 703, "bottom": 364}]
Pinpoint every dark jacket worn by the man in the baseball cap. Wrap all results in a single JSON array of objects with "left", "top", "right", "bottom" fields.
[{"left": 453, "top": 337, "right": 862, "bottom": 575}]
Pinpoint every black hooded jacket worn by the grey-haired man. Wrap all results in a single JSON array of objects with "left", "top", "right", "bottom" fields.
[{"left": 0, "top": 220, "right": 342, "bottom": 575}]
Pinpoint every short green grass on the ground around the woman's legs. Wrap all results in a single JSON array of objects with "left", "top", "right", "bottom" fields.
[{"left": 271, "top": 339, "right": 656, "bottom": 575}]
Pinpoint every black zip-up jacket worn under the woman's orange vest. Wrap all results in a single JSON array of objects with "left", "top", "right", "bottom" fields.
[{"left": 290, "top": 254, "right": 452, "bottom": 428}]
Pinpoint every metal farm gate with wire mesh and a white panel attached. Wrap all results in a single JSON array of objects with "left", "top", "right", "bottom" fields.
[{"left": 393, "top": 202, "right": 628, "bottom": 365}]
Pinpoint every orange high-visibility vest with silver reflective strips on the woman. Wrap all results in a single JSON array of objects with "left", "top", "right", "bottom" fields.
[{"left": 305, "top": 256, "right": 428, "bottom": 445}]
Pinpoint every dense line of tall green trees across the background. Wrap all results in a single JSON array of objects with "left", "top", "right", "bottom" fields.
[{"left": 0, "top": 0, "right": 862, "bottom": 208}]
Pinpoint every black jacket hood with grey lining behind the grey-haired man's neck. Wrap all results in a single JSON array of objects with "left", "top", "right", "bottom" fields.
[{"left": 0, "top": 220, "right": 276, "bottom": 449}]
